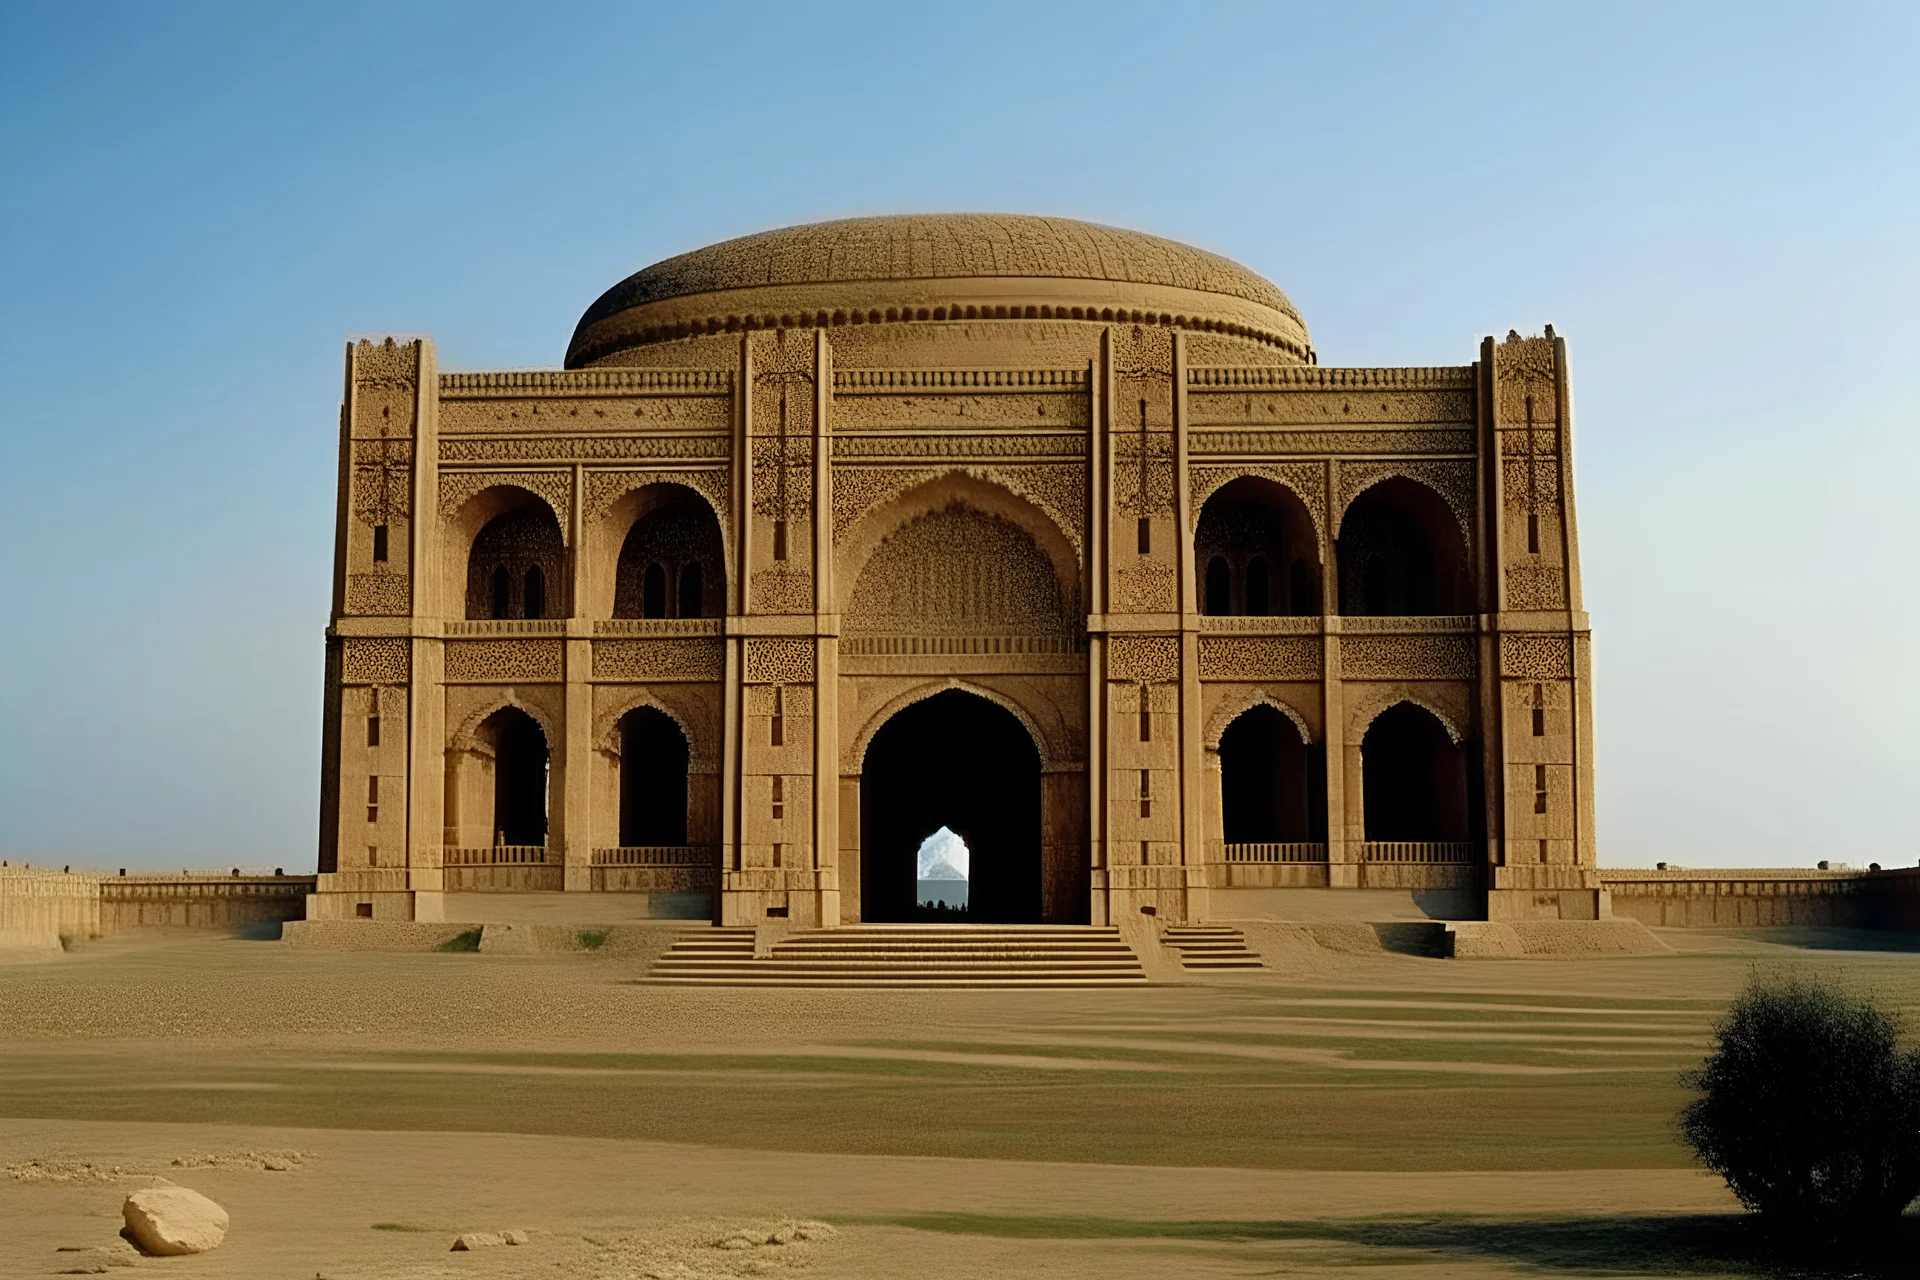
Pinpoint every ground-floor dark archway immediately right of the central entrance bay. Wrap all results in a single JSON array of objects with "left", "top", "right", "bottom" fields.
[{"left": 1219, "top": 706, "right": 1327, "bottom": 844}]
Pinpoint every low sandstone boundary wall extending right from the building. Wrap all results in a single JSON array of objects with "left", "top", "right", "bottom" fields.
[{"left": 1599, "top": 867, "right": 1920, "bottom": 929}]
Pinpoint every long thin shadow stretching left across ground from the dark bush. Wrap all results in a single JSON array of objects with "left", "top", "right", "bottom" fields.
[{"left": 849, "top": 1213, "right": 1920, "bottom": 1280}]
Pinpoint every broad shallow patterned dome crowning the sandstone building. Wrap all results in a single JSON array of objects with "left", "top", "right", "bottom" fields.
[{"left": 566, "top": 213, "right": 1308, "bottom": 368}]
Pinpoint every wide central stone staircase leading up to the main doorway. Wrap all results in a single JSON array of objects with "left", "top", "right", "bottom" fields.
[{"left": 645, "top": 925, "right": 1146, "bottom": 986}]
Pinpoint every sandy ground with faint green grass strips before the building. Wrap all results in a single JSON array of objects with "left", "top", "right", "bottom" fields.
[{"left": 0, "top": 929, "right": 1920, "bottom": 1280}]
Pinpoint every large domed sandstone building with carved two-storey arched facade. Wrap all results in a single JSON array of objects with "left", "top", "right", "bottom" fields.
[{"left": 309, "top": 215, "right": 1607, "bottom": 927}]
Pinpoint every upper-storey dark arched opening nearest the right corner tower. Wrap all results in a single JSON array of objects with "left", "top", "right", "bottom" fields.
[{"left": 1338, "top": 476, "right": 1473, "bottom": 618}]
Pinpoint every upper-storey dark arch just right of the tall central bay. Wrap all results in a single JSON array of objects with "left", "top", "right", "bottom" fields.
[{"left": 1194, "top": 476, "right": 1321, "bottom": 618}]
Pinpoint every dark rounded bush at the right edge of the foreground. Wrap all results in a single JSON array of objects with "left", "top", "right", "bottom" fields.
[{"left": 1680, "top": 977, "right": 1920, "bottom": 1240}]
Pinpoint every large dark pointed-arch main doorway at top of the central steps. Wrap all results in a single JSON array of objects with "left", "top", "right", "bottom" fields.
[{"left": 860, "top": 689, "right": 1041, "bottom": 923}]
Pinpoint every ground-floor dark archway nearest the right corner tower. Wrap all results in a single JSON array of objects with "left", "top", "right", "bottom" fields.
[{"left": 1359, "top": 702, "right": 1476, "bottom": 841}]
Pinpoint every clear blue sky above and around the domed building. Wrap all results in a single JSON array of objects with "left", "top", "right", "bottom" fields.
[{"left": 0, "top": 0, "right": 1920, "bottom": 869}]
